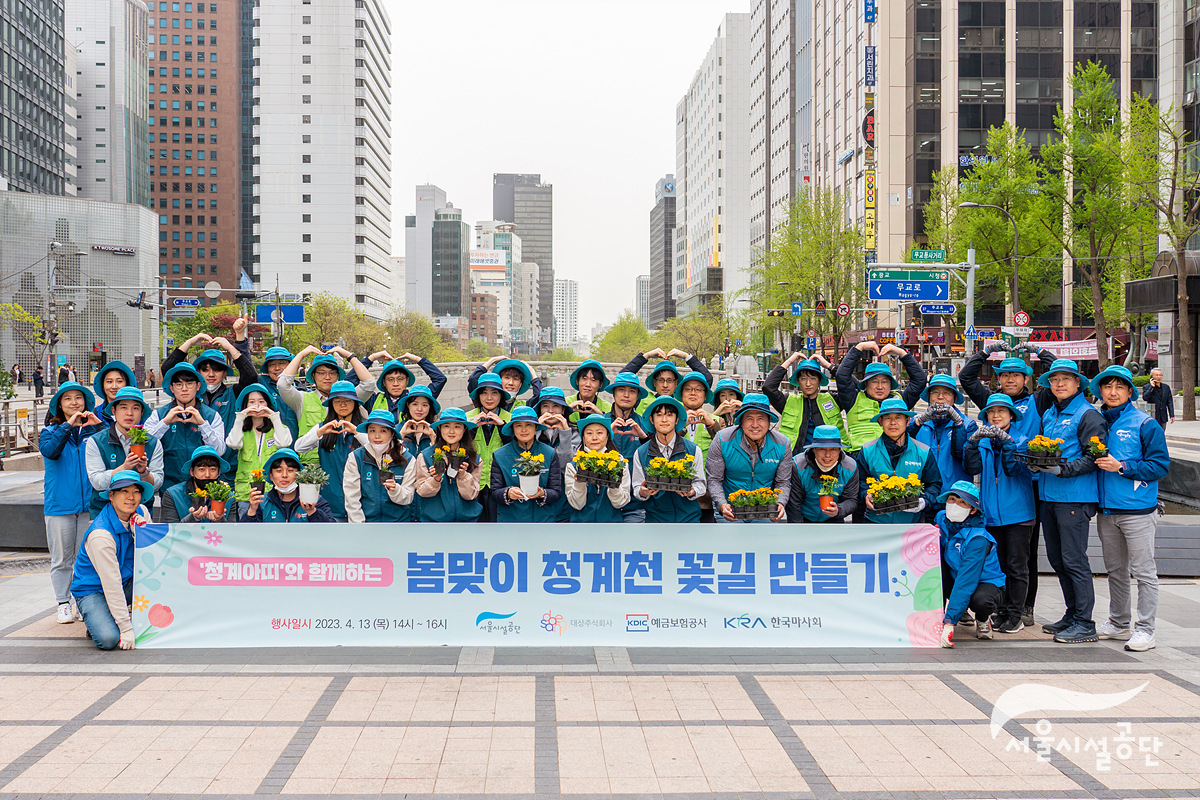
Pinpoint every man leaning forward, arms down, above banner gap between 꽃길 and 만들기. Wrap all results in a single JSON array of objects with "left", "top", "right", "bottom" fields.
[{"left": 704, "top": 393, "right": 792, "bottom": 522}]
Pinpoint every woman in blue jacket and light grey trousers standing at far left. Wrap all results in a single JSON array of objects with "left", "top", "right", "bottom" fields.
[{"left": 37, "top": 381, "right": 104, "bottom": 625}]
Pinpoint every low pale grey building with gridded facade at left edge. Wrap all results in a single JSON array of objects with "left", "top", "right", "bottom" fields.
[{"left": 0, "top": 191, "right": 161, "bottom": 384}]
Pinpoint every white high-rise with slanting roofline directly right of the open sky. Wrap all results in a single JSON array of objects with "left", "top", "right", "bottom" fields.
[{"left": 673, "top": 13, "right": 750, "bottom": 315}]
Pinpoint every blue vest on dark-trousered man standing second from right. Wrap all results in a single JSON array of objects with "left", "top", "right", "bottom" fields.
[{"left": 1042, "top": 391, "right": 1108, "bottom": 503}]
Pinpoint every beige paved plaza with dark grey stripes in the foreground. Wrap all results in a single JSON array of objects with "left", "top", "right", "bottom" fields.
[{"left": 0, "top": 575, "right": 1200, "bottom": 800}]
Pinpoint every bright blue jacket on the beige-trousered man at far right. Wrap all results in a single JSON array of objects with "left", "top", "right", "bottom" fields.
[{"left": 1097, "top": 402, "right": 1171, "bottom": 515}]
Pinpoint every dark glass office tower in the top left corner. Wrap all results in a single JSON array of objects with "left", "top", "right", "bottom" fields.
[{"left": 0, "top": 0, "right": 67, "bottom": 194}]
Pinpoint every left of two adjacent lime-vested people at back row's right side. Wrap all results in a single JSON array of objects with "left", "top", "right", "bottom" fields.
[{"left": 762, "top": 353, "right": 850, "bottom": 456}]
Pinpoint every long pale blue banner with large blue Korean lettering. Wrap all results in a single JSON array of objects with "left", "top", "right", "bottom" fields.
[{"left": 133, "top": 523, "right": 942, "bottom": 648}]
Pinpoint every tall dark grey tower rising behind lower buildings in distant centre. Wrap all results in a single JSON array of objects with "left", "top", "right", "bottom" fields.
[{"left": 492, "top": 173, "right": 554, "bottom": 344}]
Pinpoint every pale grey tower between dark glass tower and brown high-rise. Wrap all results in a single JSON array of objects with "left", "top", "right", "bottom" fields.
[{"left": 65, "top": 0, "right": 150, "bottom": 206}]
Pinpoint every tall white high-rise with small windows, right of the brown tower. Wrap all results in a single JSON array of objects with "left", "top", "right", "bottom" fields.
[{"left": 253, "top": 0, "right": 393, "bottom": 319}]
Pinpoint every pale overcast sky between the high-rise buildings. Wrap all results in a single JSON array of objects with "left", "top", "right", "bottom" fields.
[{"left": 384, "top": 0, "right": 750, "bottom": 339}]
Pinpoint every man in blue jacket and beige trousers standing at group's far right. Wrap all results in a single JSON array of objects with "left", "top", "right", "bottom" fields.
[{"left": 1091, "top": 365, "right": 1171, "bottom": 652}]
